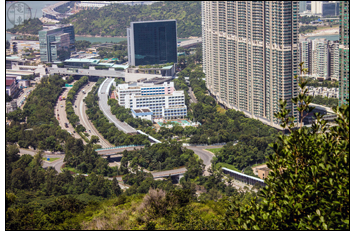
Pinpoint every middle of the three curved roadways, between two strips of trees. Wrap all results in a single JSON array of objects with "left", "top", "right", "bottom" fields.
[{"left": 73, "top": 82, "right": 114, "bottom": 148}]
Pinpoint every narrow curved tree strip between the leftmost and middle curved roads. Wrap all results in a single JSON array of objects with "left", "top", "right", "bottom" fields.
[{"left": 66, "top": 76, "right": 89, "bottom": 126}]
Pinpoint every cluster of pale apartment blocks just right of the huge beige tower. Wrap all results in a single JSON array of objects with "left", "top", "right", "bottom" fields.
[{"left": 299, "top": 39, "right": 339, "bottom": 80}]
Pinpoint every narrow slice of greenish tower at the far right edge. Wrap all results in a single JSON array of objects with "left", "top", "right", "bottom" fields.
[{"left": 339, "top": 1, "right": 349, "bottom": 105}]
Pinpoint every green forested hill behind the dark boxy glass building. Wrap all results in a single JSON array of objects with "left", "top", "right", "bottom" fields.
[{"left": 62, "top": 1, "right": 202, "bottom": 38}]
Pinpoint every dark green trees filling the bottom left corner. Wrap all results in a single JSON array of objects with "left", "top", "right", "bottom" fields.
[{"left": 5, "top": 145, "right": 121, "bottom": 230}]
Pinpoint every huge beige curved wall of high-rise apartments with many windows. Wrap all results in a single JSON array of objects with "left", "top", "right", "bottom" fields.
[{"left": 202, "top": 1, "right": 299, "bottom": 126}]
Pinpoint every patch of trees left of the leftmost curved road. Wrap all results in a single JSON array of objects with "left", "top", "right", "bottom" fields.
[{"left": 6, "top": 75, "right": 70, "bottom": 151}]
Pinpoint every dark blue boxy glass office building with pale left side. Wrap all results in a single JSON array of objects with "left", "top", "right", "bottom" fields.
[{"left": 127, "top": 20, "right": 177, "bottom": 66}]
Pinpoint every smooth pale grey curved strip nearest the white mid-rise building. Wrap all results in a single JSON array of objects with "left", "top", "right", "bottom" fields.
[{"left": 98, "top": 78, "right": 137, "bottom": 134}]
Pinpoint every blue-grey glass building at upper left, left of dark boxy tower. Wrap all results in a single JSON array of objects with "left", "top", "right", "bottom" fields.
[{"left": 39, "top": 24, "right": 75, "bottom": 62}]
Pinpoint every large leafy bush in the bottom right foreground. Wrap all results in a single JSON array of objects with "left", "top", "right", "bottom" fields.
[{"left": 222, "top": 64, "right": 349, "bottom": 229}]
